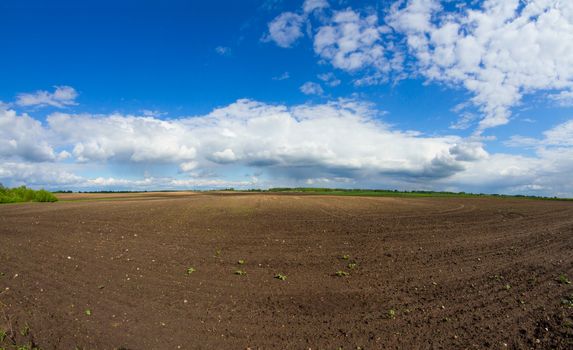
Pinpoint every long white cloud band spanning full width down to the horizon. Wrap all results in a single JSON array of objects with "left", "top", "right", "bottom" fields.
[{"left": 6, "top": 100, "right": 573, "bottom": 196}]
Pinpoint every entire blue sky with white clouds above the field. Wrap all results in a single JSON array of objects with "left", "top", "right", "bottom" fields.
[{"left": 0, "top": 0, "right": 573, "bottom": 196}]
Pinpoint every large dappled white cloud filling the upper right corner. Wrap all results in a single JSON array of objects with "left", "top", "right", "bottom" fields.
[{"left": 386, "top": 0, "right": 573, "bottom": 131}]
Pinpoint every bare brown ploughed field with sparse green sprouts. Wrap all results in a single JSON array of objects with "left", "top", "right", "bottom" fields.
[{"left": 0, "top": 193, "right": 573, "bottom": 349}]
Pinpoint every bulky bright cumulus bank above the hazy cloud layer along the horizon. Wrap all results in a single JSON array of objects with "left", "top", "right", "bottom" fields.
[{"left": 0, "top": 100, "right": 487, "bottom": 189}]
